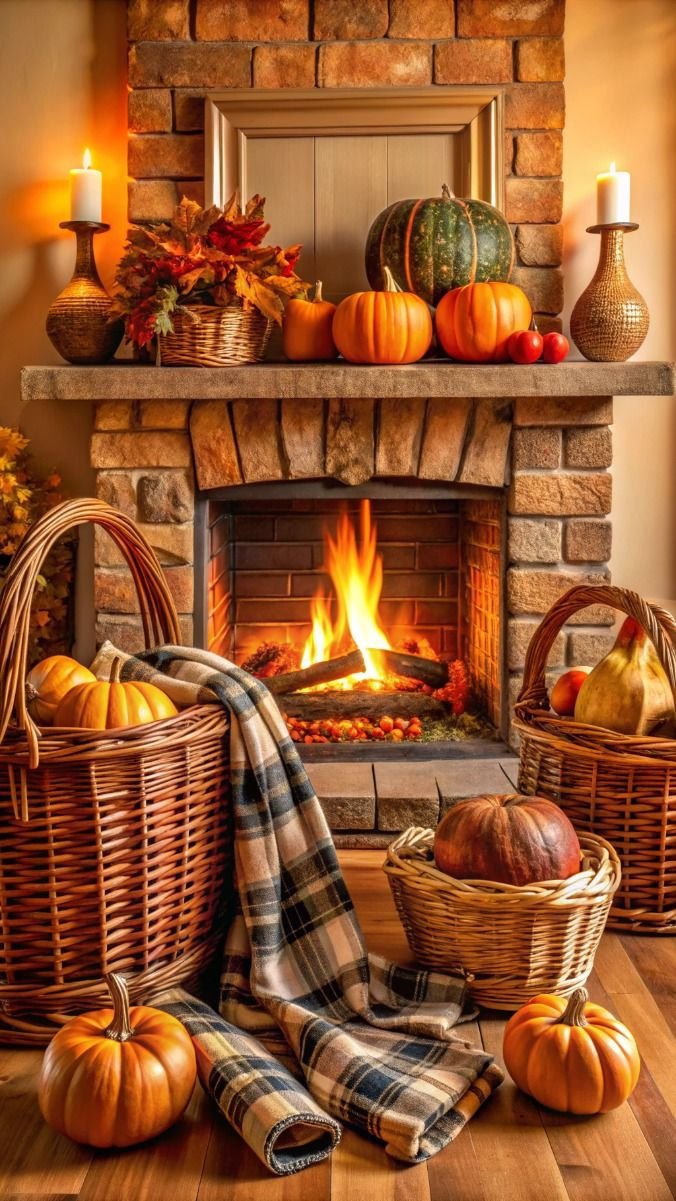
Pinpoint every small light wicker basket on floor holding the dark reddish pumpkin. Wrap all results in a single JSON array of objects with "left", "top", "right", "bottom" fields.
[{"left": 383, "top": 826, "right": 620, "bottom": 1009}]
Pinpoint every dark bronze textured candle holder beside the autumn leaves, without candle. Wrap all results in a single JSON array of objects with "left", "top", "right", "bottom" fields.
[{"left": 47, "top": 221, "right": 124, "bottom": 363}]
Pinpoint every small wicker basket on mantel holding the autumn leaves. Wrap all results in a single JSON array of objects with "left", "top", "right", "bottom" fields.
[{"left": 157, "top": 304, "right": 273, "bottom": 368}]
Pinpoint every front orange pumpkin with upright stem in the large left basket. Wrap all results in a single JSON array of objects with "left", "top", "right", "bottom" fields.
[{"left": 54, "top": 659, "right": 178, "bottom": 730}]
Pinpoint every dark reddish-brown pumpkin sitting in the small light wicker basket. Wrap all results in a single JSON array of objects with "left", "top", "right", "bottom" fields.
[{"left": 435, "top": 793, "right": 580, "bottom": 885}]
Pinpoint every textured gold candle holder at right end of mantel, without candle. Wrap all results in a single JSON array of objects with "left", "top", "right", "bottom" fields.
[{"left": 570, "top": 222, "right": 650, "bottom": 363}]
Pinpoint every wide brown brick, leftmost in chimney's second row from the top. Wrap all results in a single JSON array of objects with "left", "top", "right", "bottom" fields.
[{"left": 128, "top": 42, "right": 251, "bottom": 88}]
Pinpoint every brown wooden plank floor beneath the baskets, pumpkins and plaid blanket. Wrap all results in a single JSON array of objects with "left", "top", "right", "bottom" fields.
[{"left": 0, "top": 852, "right": 676, "bottom": 1201}]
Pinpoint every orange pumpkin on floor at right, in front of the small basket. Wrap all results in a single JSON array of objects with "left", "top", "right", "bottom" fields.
[{"left": 502, "top": 988, "right": 641, "bottom": 1113}]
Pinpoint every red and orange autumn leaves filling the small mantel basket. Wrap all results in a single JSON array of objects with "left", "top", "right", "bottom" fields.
[{"left": 110, "top": 193, "right": 309, "bottom": 349}]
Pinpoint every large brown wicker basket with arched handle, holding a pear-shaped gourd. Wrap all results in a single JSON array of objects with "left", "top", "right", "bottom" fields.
[{"left": 515, "top": 586, "right": 676, "bottom": 934}]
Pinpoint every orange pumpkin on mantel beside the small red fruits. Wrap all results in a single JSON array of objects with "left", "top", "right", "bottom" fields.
[{"left": 435, "top": 281, "right": 533, "bottom": 363}]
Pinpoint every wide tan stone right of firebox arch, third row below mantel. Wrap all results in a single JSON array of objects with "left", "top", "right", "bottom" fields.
[{"left": 508, "top": 472, "right": 612, "bottom": 516}]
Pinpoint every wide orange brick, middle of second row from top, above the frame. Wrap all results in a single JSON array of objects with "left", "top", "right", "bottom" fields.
[{"left": 318, "top": 42, "right": 432, "bottom": 88}]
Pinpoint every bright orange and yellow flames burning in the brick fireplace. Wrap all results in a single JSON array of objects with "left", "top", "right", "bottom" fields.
[{"left": 301, "top": 501, "right": 391, "bottom": 688}]
